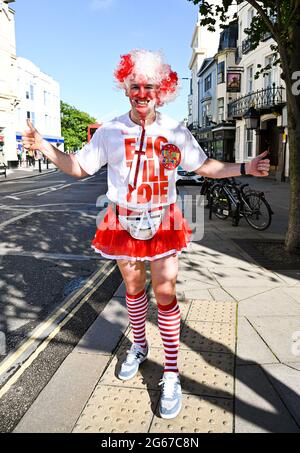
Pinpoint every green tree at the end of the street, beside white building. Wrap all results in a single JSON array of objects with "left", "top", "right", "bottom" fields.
[{"left": 60, "top": 101, "right": 96, "bottom": 152}]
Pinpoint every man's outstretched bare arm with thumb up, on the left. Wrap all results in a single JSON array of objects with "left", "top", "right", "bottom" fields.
[{"left": 22, "top": 120, "right": 89, "bottom": 178}]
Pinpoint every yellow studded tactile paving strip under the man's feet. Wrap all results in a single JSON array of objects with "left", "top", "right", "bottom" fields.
[{"left": 74, "top": 300, "right": 236, "bottom": 433}]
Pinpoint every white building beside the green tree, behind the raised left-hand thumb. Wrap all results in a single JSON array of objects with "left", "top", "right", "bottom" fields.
[{"left": 16, "top": 57, "right": 64, "bottom": 154}]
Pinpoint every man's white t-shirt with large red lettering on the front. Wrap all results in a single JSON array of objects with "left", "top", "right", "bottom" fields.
[{"left": 76, "top": 112, "right": 207, "bottom": 209}]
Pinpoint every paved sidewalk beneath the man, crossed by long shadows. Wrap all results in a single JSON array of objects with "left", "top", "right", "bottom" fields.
[{"left": 15, "top": 181, "right": 300, "bottom": 434}]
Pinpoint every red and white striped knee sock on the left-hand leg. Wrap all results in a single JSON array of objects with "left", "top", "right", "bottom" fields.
[{"left": 126, "top": 289, "right": 148, "bottom": 348}]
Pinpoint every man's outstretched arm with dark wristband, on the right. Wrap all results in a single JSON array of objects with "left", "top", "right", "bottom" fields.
[{"left": 196, "top": 151, "right": 270, "bottom": 178}]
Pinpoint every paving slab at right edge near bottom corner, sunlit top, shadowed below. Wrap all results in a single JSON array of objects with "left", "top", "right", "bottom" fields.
[{"left": 263, "top": 364, "right": 300, "bottom": 426}]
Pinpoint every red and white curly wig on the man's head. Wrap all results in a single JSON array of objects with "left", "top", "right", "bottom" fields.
[{"left": 114, "top": 50, "right": 179, "bottom": 106}]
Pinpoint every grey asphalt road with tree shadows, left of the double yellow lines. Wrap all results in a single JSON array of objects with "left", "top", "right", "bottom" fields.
[{"left": 0, "top": 169, "right": 122, "bottom": 368}]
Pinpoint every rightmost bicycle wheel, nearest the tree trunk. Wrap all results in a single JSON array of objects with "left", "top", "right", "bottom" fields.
[{"left": 243, "top": 192, "right": 272, "bottom": 231}]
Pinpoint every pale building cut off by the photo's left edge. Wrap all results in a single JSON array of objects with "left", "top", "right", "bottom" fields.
[{"left": 0, "top": 0, "right": 18, "bottom": 164}]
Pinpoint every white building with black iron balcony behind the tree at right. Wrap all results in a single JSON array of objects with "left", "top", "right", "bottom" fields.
[{"left": 229, "top": 2, "right": 288, "bottom": 176}]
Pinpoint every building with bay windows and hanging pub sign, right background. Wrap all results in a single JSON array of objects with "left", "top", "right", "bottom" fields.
[{"left": 197, "top": 21, "right": 240, "bottom": 162}]
